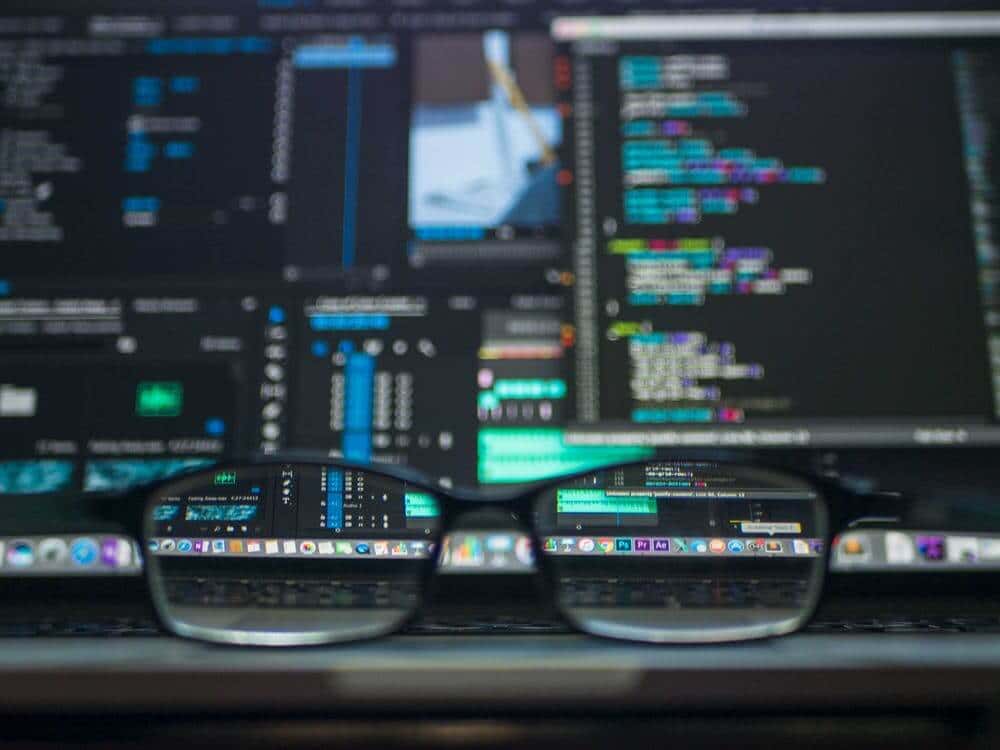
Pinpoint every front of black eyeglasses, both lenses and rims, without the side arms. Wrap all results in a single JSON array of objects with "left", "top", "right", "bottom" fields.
[{"left": 123, "top": 461, "right": 836, "bottom": 646}]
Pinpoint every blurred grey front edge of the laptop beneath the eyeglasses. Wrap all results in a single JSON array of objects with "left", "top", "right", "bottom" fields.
[{"left": 0, "top": 634, "right": 1000, "bottom": 714}]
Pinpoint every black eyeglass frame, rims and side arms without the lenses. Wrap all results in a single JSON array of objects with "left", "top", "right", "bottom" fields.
[{"left": 0, "top": 462, "right": 876, "bottom": 647}]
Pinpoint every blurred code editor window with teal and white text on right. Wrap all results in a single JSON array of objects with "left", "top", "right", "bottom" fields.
[{"left": 553, "top": 14, "right": 1000, "bottom": 446}]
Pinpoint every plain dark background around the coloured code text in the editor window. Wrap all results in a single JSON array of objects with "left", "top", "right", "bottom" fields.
[{"left": 594, "top": 41, "right": 991, "bottom": 421}]
